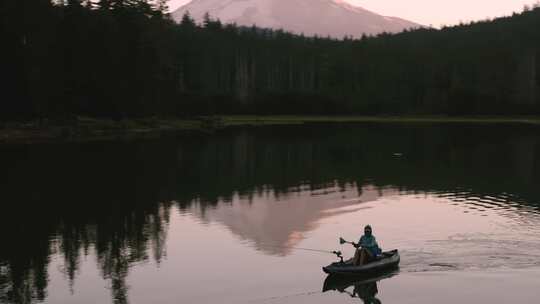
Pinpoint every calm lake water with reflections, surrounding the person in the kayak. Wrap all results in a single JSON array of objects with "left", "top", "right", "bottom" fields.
[{"left": 0, "top": 124, "right": 540, "bottom": 304}]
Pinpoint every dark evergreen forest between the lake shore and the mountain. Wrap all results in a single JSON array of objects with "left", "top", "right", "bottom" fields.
[{"left": 0, "top": 0, "right": 540, "bottom": 120}]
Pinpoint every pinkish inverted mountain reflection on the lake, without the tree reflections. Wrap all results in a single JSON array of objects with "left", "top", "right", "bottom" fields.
[{"left": 184, "top": 184, "right": 397, "bottom": 255}]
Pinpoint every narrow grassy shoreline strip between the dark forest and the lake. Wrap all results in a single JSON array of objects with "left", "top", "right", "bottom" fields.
[{"left": 0, "top": 115, "right": 540, "bottom": 144}]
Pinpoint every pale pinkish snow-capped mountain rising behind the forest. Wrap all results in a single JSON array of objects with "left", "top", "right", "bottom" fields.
[{"left": 172, "top": 0, "right": 420, "bottom": 38}]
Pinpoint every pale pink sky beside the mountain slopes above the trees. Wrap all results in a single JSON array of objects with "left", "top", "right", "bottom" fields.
[{"left": 169, "top": 0, "right": 535, "bottom": 26}]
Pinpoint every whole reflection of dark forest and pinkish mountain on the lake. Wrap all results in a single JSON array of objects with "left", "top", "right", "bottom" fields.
[{"left": 0, "top": 124, "right": 540, "bottom": 303}]
